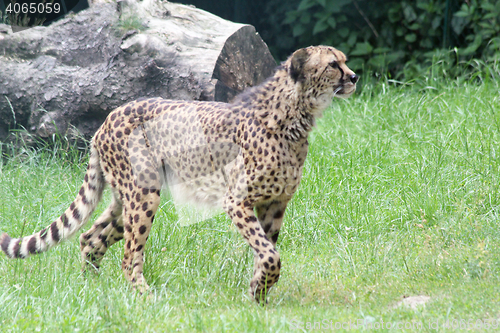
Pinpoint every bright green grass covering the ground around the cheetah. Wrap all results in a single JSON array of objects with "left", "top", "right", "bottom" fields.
[{"left": 0, "top": 76, "right": 500, "bottom": 332}]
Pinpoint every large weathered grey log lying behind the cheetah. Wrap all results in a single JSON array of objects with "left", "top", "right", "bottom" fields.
[{"left": 0, "top": 0, "right": 276, "bottom": 139}]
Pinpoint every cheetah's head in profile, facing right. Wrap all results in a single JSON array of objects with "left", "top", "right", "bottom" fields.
[{"left": 285, "top": 46, "right": 358, "bottom": 110}]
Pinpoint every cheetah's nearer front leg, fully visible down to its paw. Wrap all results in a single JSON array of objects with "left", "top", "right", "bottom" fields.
[{"left": 224, "top": 197, "right": 281, "bottom": 303}]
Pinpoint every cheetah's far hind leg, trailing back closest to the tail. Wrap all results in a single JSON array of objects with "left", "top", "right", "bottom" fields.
[{"left": 80, "top": 196, "right": 123, "bottom": 272}]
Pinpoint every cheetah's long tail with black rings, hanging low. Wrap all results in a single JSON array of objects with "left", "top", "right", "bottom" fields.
[{"left": 0, "top": 141, "right": 104, "bottom": 258}]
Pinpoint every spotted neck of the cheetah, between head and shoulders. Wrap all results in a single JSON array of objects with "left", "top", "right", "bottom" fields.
[{"left": 234, "top": 69, "right": 320, "bottom": 142}]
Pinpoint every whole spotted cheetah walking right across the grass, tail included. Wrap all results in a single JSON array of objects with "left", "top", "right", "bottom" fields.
[{"left": 0, "top": 46, "right": 358, "bottom": 303}]
